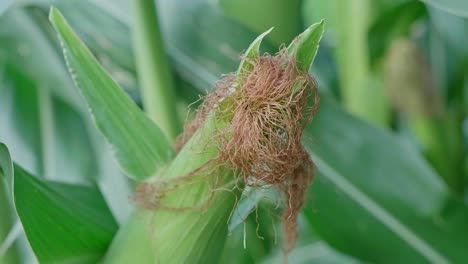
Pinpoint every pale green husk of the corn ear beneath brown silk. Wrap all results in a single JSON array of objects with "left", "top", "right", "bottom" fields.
[{"left": 103, "top": 23, "right": 323, "bottom": 263}]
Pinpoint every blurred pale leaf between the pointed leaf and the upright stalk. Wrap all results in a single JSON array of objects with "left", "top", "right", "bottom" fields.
[{"left": 50, "top": 0, "right": 138, "bottom": 92}]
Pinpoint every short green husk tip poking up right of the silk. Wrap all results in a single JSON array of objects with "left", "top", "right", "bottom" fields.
[{"left": 288, "top": 20, "right": 325, "bottom": 72}]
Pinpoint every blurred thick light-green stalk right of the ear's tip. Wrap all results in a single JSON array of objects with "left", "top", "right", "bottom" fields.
[{"left": 336, "top": 0, "right": 388, "bottom": 125}]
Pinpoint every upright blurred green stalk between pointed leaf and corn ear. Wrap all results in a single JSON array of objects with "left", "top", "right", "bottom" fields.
[{"left": 132, "top": 0, "right": 179, "bottom": 139}]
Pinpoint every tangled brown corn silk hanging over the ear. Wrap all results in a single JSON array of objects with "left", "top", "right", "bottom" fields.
[{"left": 143, "top": 49, "right": 319, "bottom": 254}]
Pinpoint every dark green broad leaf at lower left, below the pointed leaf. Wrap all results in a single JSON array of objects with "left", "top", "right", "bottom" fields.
[{"left": 13, "top": 166, "right": 117, "bottom": 263}]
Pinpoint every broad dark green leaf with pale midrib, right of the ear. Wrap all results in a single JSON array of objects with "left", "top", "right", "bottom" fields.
[{"left": 305, "top": 97, "right": 468, "bottom": 263}]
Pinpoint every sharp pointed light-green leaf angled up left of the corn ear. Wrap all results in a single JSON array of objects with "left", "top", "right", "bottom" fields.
[{"left": 49, "top": 7, "right": 173, "bottom": 180}]
